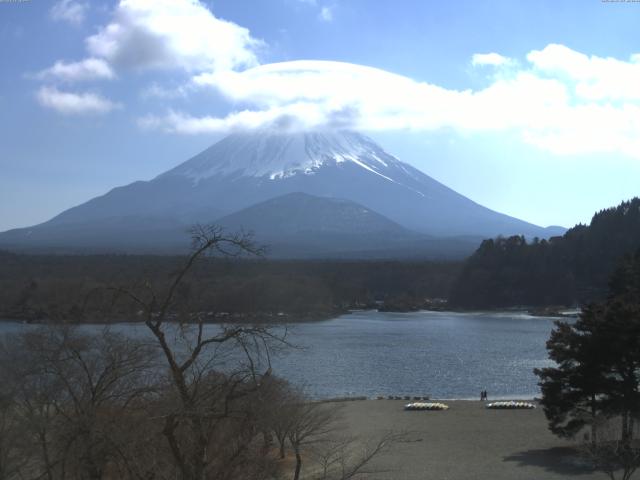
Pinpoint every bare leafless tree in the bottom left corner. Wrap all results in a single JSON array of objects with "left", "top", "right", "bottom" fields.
[{"left": 0, "top": 326, "right": 154, "bottom": 480}]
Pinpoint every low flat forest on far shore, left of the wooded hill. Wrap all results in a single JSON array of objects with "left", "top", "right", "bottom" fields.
[{"left": 0, "top": 252, "right": 460, "bottom": 322}]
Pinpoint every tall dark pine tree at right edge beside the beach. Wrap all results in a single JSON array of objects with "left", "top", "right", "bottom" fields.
[{"left": 535, "top": 251, "right": 640, "bottom": 447}]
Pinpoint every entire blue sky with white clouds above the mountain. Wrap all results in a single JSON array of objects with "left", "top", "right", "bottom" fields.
[{"left": 0, "top": 0, "right": 640, "bottom": 231}]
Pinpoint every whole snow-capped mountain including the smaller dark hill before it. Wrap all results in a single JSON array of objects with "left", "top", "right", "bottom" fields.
[{"left": 0, "top": 130, "right": 564, "bottom": 257}]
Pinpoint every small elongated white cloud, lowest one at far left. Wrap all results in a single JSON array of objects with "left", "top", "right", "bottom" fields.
[{"left": 36, "top": 87, "right": 120, "bottom": 115}]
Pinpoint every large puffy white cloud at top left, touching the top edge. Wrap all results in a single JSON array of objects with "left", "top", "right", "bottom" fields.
[{"left": 87, "top": 0, "right": 262, "bottom": 72}]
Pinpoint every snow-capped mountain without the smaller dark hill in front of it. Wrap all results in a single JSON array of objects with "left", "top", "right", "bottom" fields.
[{"left": 0, "top": 127, "right": 557, "bottom": 255}]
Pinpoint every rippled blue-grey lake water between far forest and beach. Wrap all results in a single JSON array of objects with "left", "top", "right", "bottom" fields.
[{"left": 0, "top": 311, "right": 554, "bottom": 399}]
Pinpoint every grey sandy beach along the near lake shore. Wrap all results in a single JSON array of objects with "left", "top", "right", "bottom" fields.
[{"left": 336, "top": 400, "right": 606, "bottom": 480}]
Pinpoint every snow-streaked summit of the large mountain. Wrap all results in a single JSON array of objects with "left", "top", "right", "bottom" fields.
[{"left": 162, "top": 130, "right": 401, "bottom": 183}]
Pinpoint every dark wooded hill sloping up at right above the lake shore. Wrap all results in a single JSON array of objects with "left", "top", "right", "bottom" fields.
[{"left": 450, "top": 198, "right": 640, "bottom": 308}]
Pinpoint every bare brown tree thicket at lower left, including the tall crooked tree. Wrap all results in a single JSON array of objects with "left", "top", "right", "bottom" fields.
[{"left": 0, "top": 226, "right": 400, "bottom": 480}]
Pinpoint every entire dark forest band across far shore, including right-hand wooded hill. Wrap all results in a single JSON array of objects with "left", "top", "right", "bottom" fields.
[{"left": 5, "top": 198, "right": 640, "bottom": 322}]
